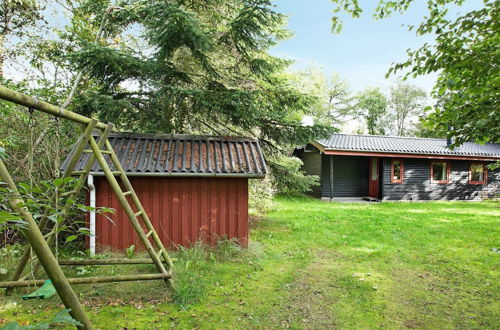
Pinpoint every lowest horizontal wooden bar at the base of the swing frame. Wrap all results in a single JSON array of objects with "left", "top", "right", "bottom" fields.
[{"left": 0, "top": 274, "right": 171, "bottom": 288}]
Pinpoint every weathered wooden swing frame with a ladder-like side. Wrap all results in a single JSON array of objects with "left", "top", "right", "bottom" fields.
[{"left": 0, "top": 85, "right": 173, "bottom": 329}]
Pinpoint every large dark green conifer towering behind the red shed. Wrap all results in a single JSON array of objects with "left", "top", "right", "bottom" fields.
[{"left": 63, "top": 0, "right": 332, "bottom": 193}]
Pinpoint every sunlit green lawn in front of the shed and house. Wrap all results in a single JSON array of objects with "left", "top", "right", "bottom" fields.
[{"left": 0, "top": 198, "right": 500, "bottom": 329}]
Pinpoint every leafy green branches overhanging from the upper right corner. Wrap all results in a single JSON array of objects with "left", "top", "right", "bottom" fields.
[{"left": 332, "top": 0, "right": 500, "bottom": 146}]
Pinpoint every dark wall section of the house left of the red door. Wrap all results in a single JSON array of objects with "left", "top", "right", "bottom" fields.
[{"left": 321, "top": 155, "right": 369, "bottom": 198}]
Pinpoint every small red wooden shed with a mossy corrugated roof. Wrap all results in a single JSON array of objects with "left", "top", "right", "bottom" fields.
[{"left": 63, "top": 133, "right": 267, "bottom": 250}]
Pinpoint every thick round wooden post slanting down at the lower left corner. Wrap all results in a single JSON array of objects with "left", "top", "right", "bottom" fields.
[{"left": 0, "top": 159, "right": 93, "bottom": 329}]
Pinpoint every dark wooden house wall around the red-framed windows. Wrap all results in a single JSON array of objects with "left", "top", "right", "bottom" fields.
[{"left": 383, "top": 158, "right": 500, "bottom": 200}]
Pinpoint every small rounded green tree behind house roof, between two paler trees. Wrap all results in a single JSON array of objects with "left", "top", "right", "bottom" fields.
[{"left": 354, "top": 88, "right": 389, "bottom": 135}]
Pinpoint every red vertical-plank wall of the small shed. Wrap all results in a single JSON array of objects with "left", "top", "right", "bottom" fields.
[{"left": 89, "top": 177, "right": 248, "bottom": 250}]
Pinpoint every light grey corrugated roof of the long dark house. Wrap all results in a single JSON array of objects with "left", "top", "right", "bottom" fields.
[{"left": 317, "top": 134, "right": 500, "bottom": 158}]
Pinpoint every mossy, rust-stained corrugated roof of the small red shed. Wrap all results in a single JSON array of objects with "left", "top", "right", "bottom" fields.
[{"left": 63, "top": 133, "right": 267, "bottom": 177}]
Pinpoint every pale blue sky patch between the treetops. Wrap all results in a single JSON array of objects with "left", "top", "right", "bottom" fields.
[{"left": 271, "top": 0, "right": 481, "bottom": 91}]
